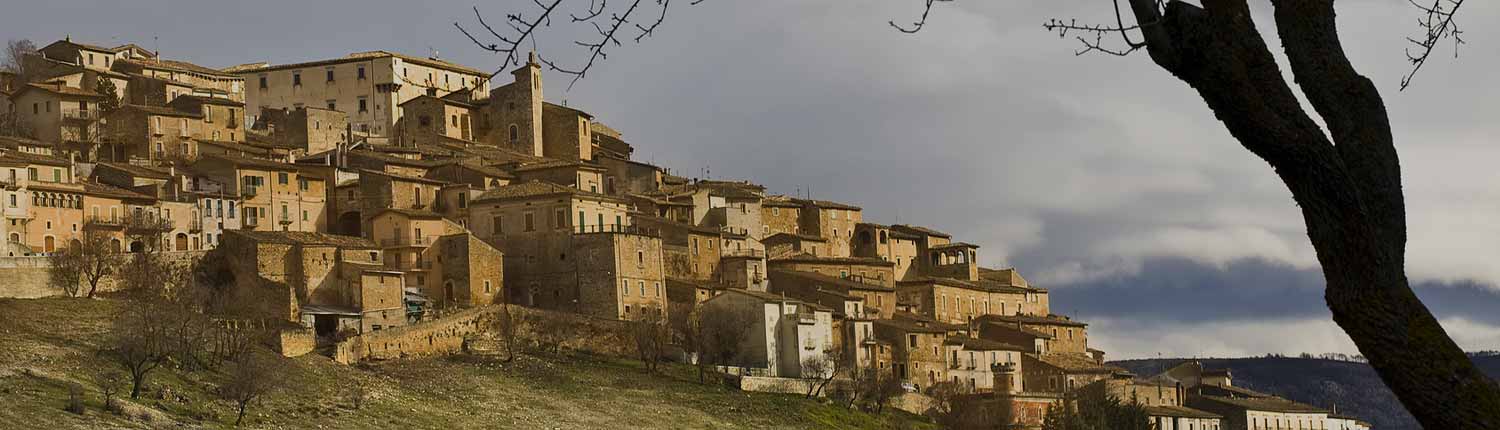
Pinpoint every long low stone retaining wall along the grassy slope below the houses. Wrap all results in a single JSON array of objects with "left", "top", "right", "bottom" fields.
[{"left": 333, "top": 306, "right": 635, "bottom": 364}]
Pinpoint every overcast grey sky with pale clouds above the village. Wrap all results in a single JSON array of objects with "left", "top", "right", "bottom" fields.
[{"left": 0, "top": 0, "right": 1500, "bottom": 358}]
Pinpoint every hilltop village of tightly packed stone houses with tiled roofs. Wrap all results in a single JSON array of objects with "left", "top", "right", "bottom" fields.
[{"left": 0, "top": 39, "right": 1368, "bottom": 430}]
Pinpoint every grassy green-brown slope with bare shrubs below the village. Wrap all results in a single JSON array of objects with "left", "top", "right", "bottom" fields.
[{"left": 0, "top": 298, "right": 932, "bottom": 429}]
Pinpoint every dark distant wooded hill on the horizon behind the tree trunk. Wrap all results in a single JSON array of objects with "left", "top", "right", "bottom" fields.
[{"left": 1112, "top": 352, "right": 1500, "bottom": 430}]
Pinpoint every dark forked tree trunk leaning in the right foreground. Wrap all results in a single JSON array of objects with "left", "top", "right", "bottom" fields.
[{"left": 1130, "top": 0, "right": 1500, "bottom": 429}]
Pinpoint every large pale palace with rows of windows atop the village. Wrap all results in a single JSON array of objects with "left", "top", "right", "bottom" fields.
[{"left": 225, "top": 51, "right": 489, "bottom": 136}]
